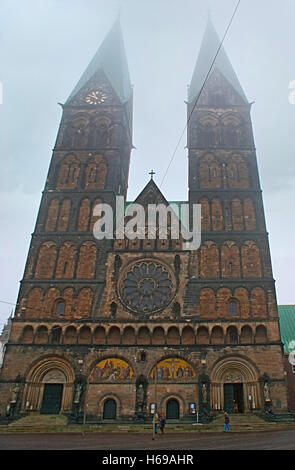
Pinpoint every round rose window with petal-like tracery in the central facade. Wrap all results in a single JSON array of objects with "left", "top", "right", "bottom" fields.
[{"left": 120, "top": 261, "right": 174, "bottom": 313}]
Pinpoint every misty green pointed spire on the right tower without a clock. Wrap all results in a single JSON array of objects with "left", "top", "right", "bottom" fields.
[{"left": 188, "top": 15, "right": 248, "bottom": 103}]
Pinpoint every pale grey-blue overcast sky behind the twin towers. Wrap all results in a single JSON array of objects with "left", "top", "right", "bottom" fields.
[{"left": 0, "top": 0, "right": 295, "bottom": 329}]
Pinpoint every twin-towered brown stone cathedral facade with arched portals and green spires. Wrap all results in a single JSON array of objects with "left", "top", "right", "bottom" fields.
[{"left": 0, "top": 19, "right": 288, "bottom": 422}]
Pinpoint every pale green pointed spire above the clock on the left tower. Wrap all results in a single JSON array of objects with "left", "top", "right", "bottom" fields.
[{"left": 66, "top": 17, "right": 132, "bottom": 104}]
